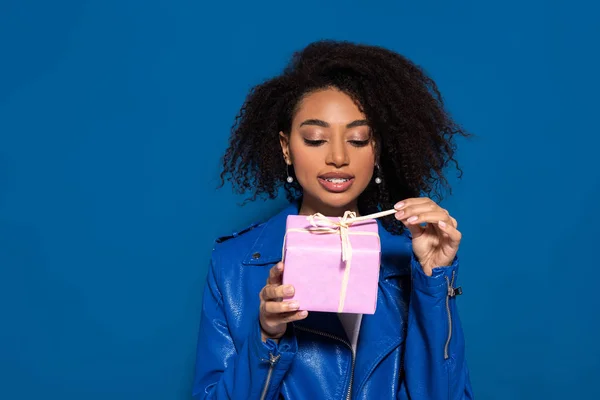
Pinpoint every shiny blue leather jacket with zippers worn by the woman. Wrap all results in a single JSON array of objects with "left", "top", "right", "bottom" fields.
[{"left": 193, "top": 204, "right": 473, "bottom": 400}]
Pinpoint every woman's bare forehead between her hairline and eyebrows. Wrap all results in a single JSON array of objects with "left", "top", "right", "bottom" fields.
[{"left": 294, "top": 89, "right": 365, "bottom": 124}]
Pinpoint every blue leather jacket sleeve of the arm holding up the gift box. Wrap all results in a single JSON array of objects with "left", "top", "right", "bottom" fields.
[{"left": 193, "top": 258, "right": 297, "bottom": 400}]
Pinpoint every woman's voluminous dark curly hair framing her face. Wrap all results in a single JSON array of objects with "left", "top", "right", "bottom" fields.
[{"left": 221, "top": 40, "right": 469, "bottom": 234}]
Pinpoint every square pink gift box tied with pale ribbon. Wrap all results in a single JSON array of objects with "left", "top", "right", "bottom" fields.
[{"left": 283, "top": 215, "right": 381, "bottom": 314}]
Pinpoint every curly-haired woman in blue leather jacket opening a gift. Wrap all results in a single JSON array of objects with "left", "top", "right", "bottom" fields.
[{"left": 193, "top": 41, "right": 473, "bottom": 400}]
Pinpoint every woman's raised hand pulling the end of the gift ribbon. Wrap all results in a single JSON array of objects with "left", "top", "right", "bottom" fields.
[{"left": 394, "top": 197, "right": 462, "bottom": 276}]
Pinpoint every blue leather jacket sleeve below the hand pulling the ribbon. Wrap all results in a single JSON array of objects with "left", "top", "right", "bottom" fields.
[{"left": 398, "top": 254, "right": 473, "bottom": 400}]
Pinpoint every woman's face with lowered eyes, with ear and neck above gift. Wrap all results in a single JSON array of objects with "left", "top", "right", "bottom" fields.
[{"left": 280, "top": 89, "right": 375, "bottom": 216}]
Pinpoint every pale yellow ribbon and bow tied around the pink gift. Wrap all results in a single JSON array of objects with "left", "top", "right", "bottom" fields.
[{"left": 281, "top": 209, "right": 396, "bottom": 313}]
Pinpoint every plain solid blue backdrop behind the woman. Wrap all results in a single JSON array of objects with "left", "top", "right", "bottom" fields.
[{"left": 0, "top": 0, "right": 600, "bottom": 400}]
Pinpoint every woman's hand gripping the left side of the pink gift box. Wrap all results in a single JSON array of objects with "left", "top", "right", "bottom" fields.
[{"left": 260, "top": 262, "right": 308, "bottom": 342}]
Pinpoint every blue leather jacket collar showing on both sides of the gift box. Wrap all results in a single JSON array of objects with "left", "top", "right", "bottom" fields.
[{"left": 242, "top": 202, "right": 412, "bottom": 280}]
